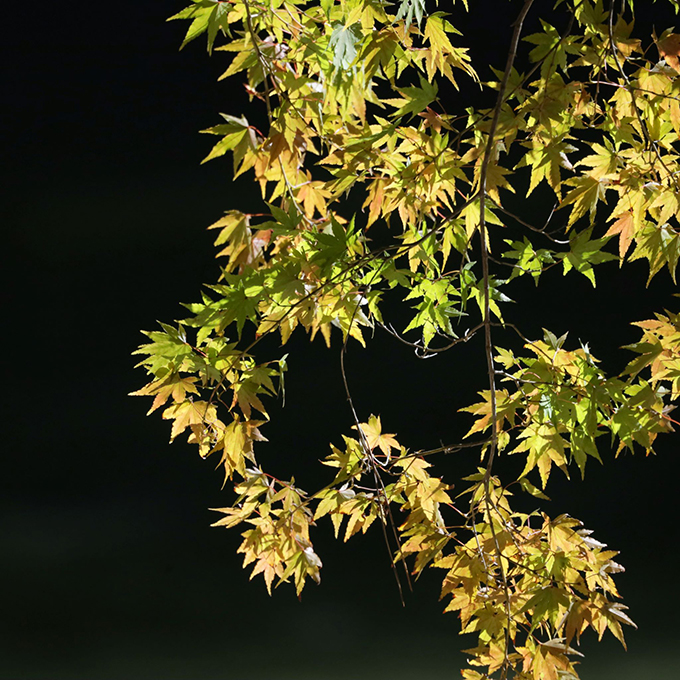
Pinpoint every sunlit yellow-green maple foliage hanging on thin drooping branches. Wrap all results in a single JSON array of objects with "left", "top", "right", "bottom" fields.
[{"left": 134, "top": 0, "right": 680, "bottom": 680}]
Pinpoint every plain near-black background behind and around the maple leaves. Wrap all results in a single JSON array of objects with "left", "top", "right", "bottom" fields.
[{"left": 5, "top": 0, "right": 680, "bottom": 680}]
